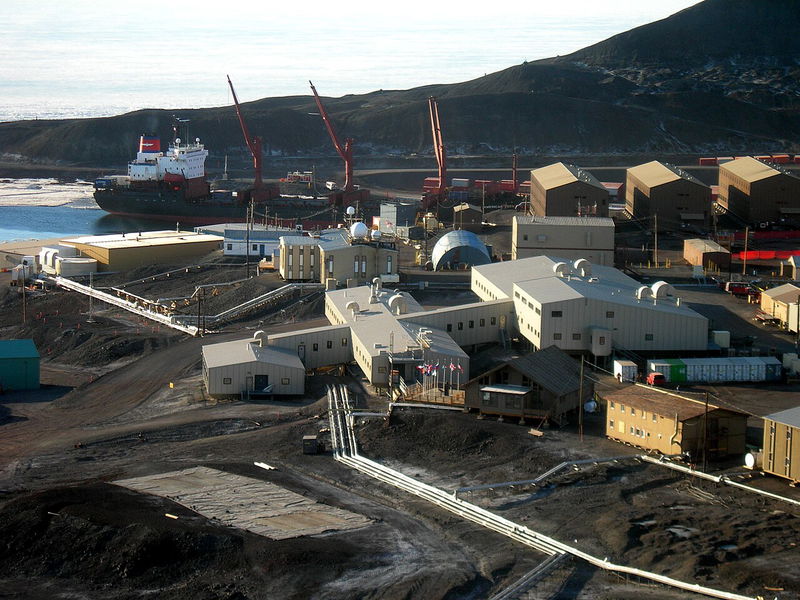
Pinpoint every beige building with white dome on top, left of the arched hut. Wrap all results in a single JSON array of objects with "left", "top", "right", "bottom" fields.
[{"left": 278, "top": 229, "right": 398, "bottom": 284}]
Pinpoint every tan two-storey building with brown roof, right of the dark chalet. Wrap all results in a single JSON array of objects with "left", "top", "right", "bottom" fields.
[{"left": 601, "top": 385, "right": 747, "bottom": 461}]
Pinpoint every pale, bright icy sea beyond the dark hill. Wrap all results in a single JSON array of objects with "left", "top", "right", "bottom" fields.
[{"left": 0, "top": 0, "right": 696, "bottom": 121}]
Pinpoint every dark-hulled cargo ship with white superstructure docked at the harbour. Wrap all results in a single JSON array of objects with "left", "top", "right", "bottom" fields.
[{"left": 94, "top": 135, "right": 379, "bottom": 229}]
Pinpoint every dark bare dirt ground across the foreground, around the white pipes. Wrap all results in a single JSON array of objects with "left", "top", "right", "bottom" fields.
[{"left": 0, "top": 237, "right": 800, "bottom": 600}]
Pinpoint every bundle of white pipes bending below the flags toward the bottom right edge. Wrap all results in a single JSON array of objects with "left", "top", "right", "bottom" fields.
[{"left": 328, "top": 385, "right": 754, "bottom": 600}]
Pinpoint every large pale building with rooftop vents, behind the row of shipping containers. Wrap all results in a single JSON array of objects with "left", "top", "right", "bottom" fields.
[{"left": 472, "top": 256, "right": 708, "bottom": 356}]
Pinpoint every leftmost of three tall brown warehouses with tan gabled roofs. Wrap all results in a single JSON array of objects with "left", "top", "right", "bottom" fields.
[{"left": 530, "top": 162, "right": 608, "bottom": 217}]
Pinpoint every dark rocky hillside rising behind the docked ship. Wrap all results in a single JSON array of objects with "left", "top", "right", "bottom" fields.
[{"left": 0, "top": 0, "right": 800, "bottom": 166}]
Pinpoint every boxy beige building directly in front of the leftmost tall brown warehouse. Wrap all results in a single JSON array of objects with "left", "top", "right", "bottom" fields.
[{"left": 511, "top": 216, "right": 614, "bottom": 266}]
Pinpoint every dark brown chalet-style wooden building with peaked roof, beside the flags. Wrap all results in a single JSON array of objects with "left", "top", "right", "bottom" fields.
[{"left": 464, "top": 346, "right": 592, "bottom": 423}]
